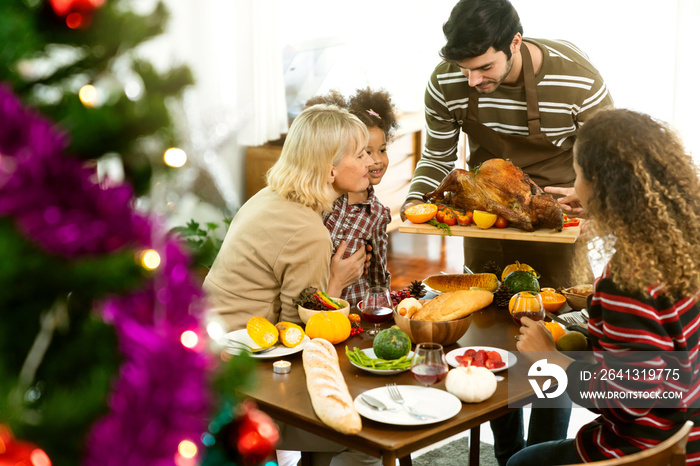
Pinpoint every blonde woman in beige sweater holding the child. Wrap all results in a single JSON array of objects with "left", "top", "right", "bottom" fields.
[{"left": 203, "top": 105, "right": 373, "bottom": 330}]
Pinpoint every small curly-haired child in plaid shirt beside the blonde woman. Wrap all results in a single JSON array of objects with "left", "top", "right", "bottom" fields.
[{"left": 306, "top": 87, "right": 398, "bottom": 306}]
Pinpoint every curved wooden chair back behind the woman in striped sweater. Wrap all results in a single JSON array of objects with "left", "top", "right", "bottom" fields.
[{"left": 566, "top": 421, "right": 693, "bottom": 466}]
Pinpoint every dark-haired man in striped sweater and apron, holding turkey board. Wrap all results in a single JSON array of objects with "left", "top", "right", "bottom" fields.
[{"left": 402, "top": 0, "right": 613, "bottom": 464}]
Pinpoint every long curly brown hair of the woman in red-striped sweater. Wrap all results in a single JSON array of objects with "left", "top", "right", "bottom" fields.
[{"left": 574, "top": 109, "right": 700, "bottom": 299}]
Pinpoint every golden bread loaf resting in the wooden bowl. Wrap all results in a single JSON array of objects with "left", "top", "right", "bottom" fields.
[{"left": 413, "top": 290, "right": 493, "bottom": 321}]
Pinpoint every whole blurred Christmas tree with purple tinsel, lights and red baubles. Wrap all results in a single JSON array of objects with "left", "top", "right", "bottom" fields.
[{"left": 0, "top": 0, "right": 274, "bottom": 466}]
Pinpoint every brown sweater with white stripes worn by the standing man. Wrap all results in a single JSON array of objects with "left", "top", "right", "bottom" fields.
[{"left": 407, "top": 39, "right": 612, "bottom": 199}]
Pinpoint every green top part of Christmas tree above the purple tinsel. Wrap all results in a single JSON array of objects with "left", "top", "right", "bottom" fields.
[{"left": 0, "top": 0, "right": 192, "bottom": 194}]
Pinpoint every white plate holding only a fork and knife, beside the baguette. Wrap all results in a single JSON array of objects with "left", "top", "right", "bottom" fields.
[{"left": 355, "top": 385, "right": 462, "bottom": 426}]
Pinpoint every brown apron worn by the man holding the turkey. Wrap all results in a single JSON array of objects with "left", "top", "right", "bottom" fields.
[{"left": 462, "top": 43, "right": 576, "bottom": 287}]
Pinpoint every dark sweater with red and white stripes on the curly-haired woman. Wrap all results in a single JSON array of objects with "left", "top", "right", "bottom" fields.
[{"left": 567, "top": 271, "right": 700, "bottom": 465}]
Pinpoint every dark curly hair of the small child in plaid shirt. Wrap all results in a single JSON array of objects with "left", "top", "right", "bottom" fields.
[{"left": 304, "top": 87, "right": 399, "bottom": 143}]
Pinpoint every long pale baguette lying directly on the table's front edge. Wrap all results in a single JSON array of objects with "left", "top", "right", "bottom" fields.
[{"left": 302, "top": 338, "right": 362, "bottom": 435}]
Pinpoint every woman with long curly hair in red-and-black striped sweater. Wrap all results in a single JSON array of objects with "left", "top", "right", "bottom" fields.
[{"left": 508, "top": 109, "right": 700, "bottom": 465}]
